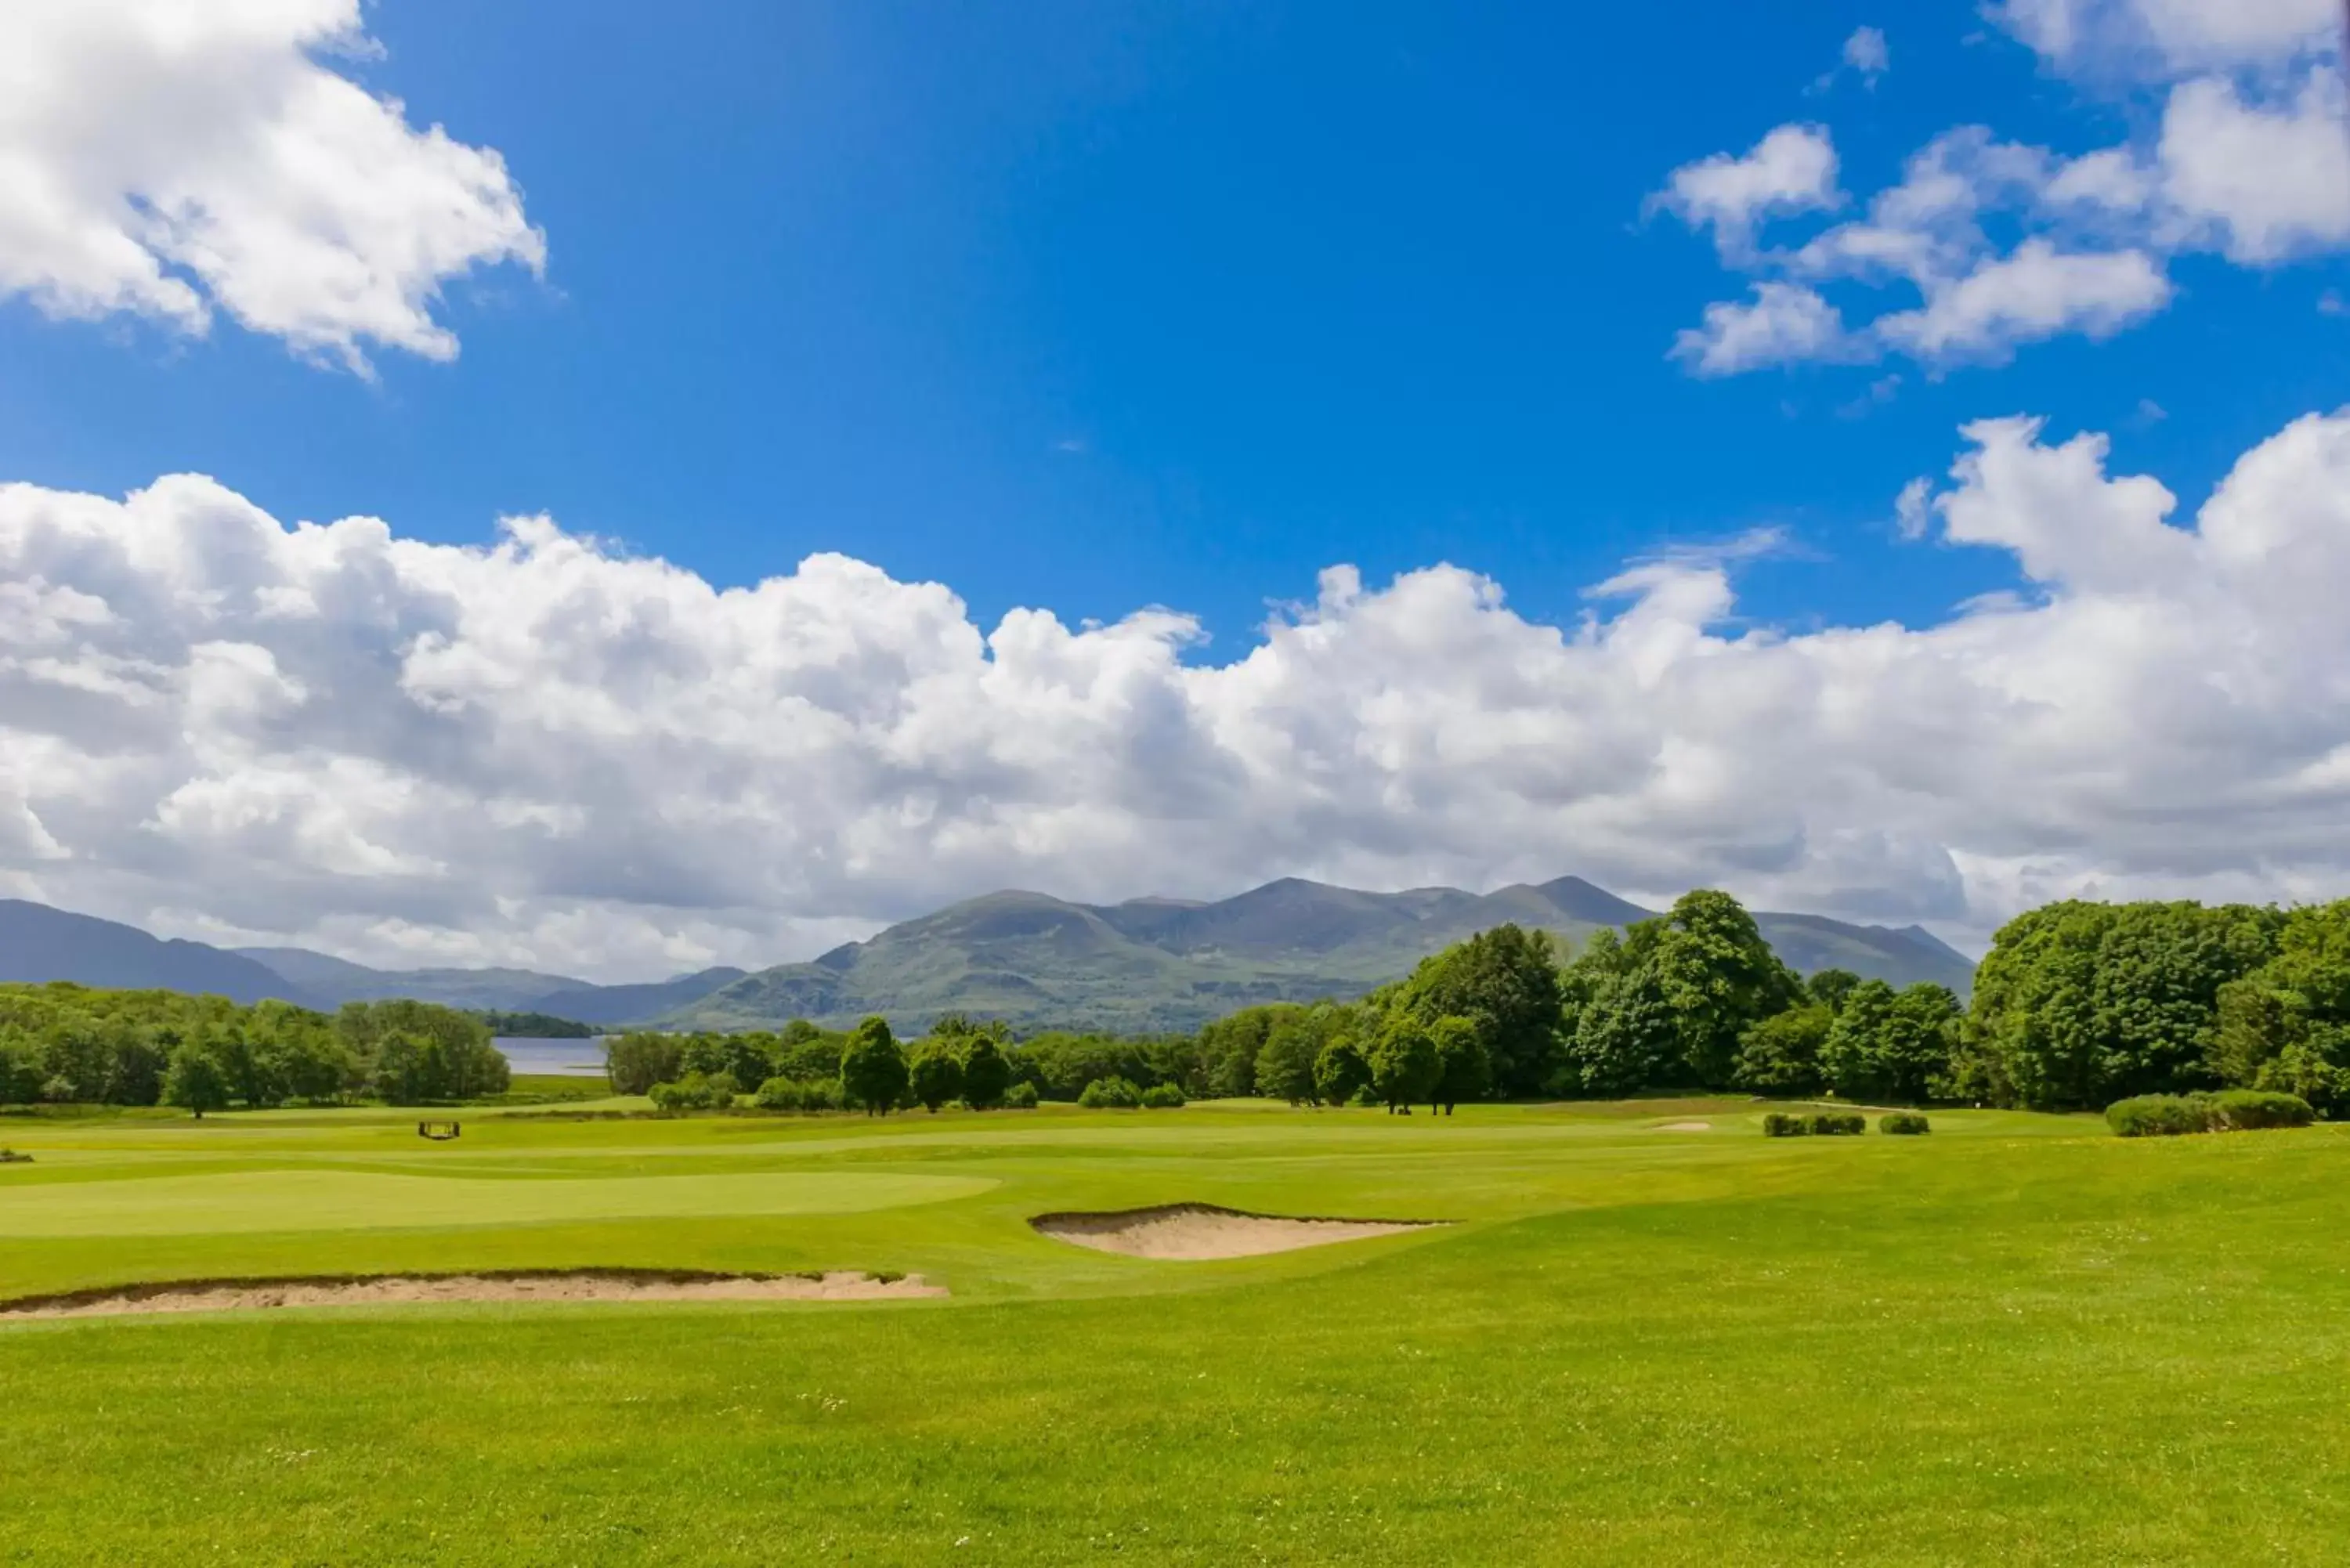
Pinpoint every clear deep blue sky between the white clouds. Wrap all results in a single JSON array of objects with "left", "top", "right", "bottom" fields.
[{"left": 0, "top": 0, "right": 2350, "bottom": 653}]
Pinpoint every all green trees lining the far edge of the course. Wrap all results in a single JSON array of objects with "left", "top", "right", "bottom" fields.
[{"left": 0, "top": 889, "right": 2350, "bottom": 1112}]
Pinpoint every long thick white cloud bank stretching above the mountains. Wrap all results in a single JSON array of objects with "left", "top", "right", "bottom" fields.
[{"left": 0, "top": 414, "right": 2350, "bottom": 976}]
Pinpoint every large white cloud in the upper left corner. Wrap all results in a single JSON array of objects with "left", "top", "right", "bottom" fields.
[{"left": 0, "top": 0, "right": 545, "bottom": 369}]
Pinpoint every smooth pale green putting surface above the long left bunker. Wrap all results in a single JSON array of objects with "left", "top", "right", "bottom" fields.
[{"left": 0, "top": 1171, "right": 996, "bottom": 1237}]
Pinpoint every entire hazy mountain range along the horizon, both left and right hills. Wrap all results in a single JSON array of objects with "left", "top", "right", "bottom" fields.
[{"left": 0, "top": 877, "right": 1974, "bottom": 1032}]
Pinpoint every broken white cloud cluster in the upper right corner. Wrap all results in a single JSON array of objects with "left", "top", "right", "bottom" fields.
[{"left": 1650, "top": 0, "right": 2350, "bottom": 374}]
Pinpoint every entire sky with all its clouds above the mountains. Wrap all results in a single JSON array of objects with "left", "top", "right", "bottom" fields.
[{"left": 0, "top": 0, "right": 2350, "bottom": 978}]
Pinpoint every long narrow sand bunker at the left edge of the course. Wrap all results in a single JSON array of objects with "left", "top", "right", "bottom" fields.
[{"left": 0, "top": 1270, "right": 945, "bottom": 1319}]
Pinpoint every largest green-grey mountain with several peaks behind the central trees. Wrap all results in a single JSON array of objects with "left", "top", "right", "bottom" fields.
[{"left": 653, "top": 877, "right": 1974, "bottom": 1032}]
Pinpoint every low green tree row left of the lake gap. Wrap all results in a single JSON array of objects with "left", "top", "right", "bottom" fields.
[{"left": 0, "top": 983, "right": 510, "bottom": 1115}]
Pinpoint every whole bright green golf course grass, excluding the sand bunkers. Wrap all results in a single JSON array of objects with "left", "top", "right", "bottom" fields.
[{"left": 0, "top": 1100, "right": 2350, "bottom": 1563}]
